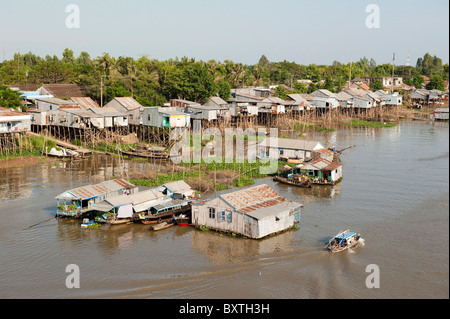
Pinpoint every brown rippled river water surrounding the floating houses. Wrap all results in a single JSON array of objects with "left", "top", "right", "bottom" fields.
[{"left": 0, "top": 121, "right": 449, "bottom": 299}]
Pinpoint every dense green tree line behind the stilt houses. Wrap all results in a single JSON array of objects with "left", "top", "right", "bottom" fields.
[{"left": 0, "top": 49, "right": 449, "bottom": 106}]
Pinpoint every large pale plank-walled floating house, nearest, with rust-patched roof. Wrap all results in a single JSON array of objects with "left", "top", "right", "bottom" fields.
[{"left": 192, "top": 184, "right": 303, "bottom": 239}]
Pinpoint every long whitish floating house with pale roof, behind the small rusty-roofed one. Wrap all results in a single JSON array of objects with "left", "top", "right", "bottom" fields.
[{"left": 258, "top": 137, "right": 324, "bottom": 161}]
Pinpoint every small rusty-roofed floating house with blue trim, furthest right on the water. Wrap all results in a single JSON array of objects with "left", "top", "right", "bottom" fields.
[{"left": 293, "top": 157, "right": 342, "bottom": 185}]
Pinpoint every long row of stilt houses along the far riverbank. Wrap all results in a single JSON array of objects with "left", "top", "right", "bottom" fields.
[{"left": 0, "top": 77, "right": 448, "bottom": 132}]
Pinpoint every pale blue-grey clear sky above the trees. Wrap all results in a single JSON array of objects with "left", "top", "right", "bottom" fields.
[{"left": 0, "top": 0, "right": 449, "bottom": 65}]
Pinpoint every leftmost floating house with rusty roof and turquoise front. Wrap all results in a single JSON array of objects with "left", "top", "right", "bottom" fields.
[{"left": 56, "top": 178, "right": 137, "bottom": 217}]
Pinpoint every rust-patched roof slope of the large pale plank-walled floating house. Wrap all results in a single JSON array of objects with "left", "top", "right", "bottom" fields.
[{"left": 220, "top": 184, "right": 287, "bottom": 213}]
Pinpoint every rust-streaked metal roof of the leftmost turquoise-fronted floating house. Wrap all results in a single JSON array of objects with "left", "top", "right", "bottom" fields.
[{"left": 56, "top": 178, "right": 136, "bottom": 199}]
